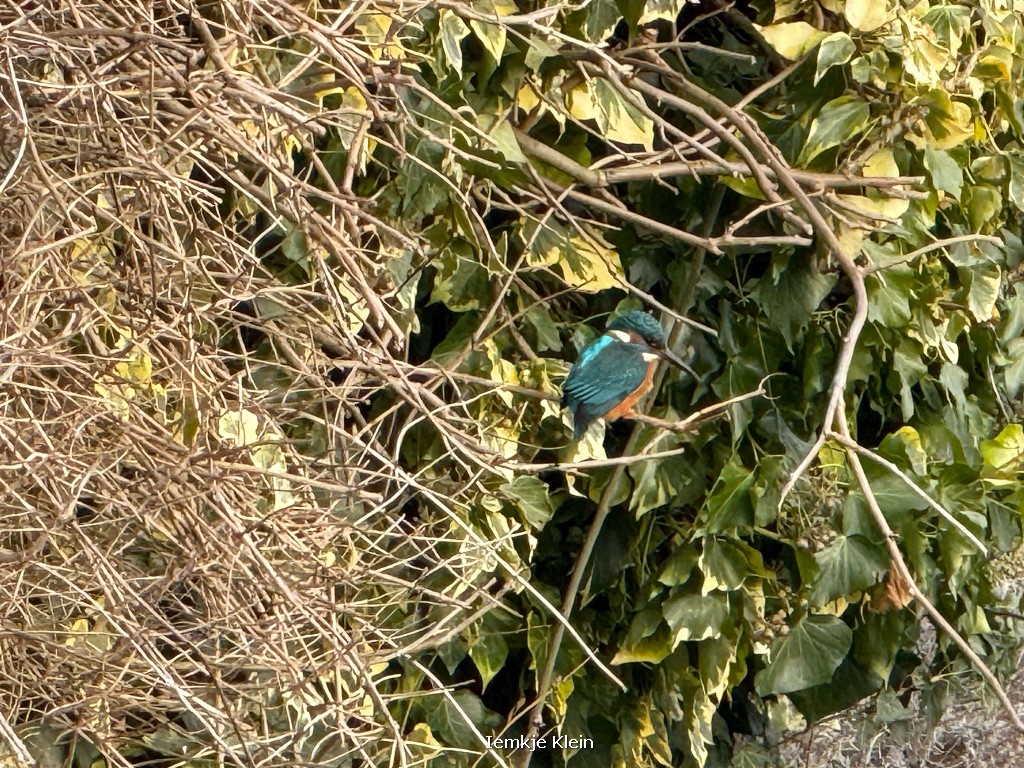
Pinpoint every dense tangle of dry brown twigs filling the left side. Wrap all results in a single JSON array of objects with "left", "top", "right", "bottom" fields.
[{"left": 0, "top": 2, "right": 544, "bottom": 766}]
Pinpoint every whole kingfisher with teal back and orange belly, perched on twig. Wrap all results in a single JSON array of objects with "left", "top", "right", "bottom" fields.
[{"left": 561, "top": 310, "right": 697, "bottom": 440}]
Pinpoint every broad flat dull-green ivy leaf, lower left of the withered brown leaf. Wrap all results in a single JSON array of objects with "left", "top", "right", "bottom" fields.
[{"left": 754, "top": 615, "right": 853, "bottom": 696}]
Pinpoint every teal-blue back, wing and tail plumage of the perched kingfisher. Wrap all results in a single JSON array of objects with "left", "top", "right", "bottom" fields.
[{"left": 562, "top": 334, "right": 650, "bottom": 439}]
